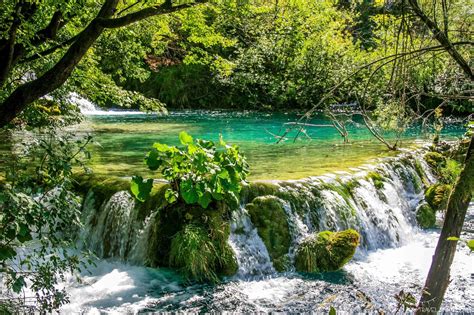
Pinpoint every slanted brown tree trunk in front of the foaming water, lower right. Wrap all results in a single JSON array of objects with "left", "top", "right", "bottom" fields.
[{"left": 416, "top": 136, "right": 474, "bottom": 314}]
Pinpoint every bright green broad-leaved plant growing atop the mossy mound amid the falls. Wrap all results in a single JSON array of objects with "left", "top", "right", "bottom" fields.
[{"left": 132, "top": 131, "right": 248, "bottom": 208}]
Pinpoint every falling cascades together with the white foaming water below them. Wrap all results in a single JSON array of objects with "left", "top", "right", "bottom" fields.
[{"left": 64, "top": 153, "right": 474, "bottom": 313}]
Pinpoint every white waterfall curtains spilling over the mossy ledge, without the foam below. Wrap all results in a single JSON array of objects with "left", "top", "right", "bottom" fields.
[{"left": 78, "top": 152, "right": 436, "bottom": 278}]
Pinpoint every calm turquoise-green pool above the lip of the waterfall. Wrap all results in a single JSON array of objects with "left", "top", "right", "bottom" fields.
[{"left": 79, "top": 110, "right": 464, "bottom": 180}]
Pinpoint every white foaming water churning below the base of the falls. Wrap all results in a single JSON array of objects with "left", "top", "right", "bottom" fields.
[{"left": 62, "top": 204, "right": 474, "bottom": 314}]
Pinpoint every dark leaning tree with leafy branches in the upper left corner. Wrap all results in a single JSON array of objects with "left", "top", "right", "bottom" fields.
[{"left": 0, "top": 0, "right": 206, "bottom": 127}]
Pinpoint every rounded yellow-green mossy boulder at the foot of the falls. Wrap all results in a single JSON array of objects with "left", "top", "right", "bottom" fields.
[{"left": 295, "top": 230, "right": 360, "bottom": 272}]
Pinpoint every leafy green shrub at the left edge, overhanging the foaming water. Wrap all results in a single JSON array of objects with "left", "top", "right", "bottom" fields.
[{"left": 0, "top": 129, "right": 90, "bottom": 312}]
